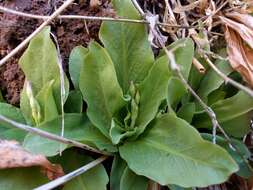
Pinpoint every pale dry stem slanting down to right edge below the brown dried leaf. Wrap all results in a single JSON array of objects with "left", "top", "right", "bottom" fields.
[{"left": 200, "top": 52, "right": 253, "bottom": 97}]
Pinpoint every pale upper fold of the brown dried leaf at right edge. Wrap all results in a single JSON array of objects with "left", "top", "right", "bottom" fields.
[{"left": 220, "top": 16, "right": 253, "bottom": 48}]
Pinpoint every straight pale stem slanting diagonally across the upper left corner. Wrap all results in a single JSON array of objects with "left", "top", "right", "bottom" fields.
[{"left": 0, "top": 0, "right": 74, "bottom": 66}]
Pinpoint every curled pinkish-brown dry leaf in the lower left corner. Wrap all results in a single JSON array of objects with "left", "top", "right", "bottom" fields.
[{"left": 0, "top": 140, "right": 64, "bottom": 180}]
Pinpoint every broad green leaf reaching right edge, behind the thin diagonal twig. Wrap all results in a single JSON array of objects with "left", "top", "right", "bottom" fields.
[{"left": 193, "top": 91, "right": 253, "bottom": 137}]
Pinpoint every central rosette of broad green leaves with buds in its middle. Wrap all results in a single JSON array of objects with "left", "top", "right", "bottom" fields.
[{"left": 68, "top": 1, "right": 238, "bottom": 189}]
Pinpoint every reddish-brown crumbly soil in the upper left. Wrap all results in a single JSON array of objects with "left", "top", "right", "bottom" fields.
[{"left": 0, "top": 0, "right": 114, "bottom": 105}]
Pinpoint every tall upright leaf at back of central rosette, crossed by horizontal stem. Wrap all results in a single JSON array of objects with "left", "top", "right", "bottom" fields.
[{"left": 99, "top": 0, "right": 154, "bottom": 93}]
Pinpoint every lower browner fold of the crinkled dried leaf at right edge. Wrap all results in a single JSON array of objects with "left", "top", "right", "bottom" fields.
[{"left": 225, "top": 27, "right": 253, "bottom": 87}]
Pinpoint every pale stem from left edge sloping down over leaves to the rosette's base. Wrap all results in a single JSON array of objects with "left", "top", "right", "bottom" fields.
[{"left": 0, "top": 115, "right": 109, "bottom": 155}]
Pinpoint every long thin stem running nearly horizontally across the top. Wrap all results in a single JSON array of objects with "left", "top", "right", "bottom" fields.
[{"left": 0, "top": 6, "right": 193, "bottom": 28}]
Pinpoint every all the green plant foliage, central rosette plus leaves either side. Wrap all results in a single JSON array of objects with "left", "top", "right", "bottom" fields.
[{"left": 0, "top": 0, "right": 253, "bottom": 190}]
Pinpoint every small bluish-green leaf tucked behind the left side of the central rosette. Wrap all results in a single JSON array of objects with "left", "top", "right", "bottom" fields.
[{"left": 69, "top": 46, "right": 88, "bottom": 90}]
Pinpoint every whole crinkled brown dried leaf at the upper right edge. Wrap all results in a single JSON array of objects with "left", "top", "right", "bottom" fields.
[{"left": 220, "top": 12, "right": 253, "bottom": 87}]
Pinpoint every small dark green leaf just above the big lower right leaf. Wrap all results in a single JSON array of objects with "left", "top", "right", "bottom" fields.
[{"left": 177, "top": 102, "right": 195, "bottom": 123}]
